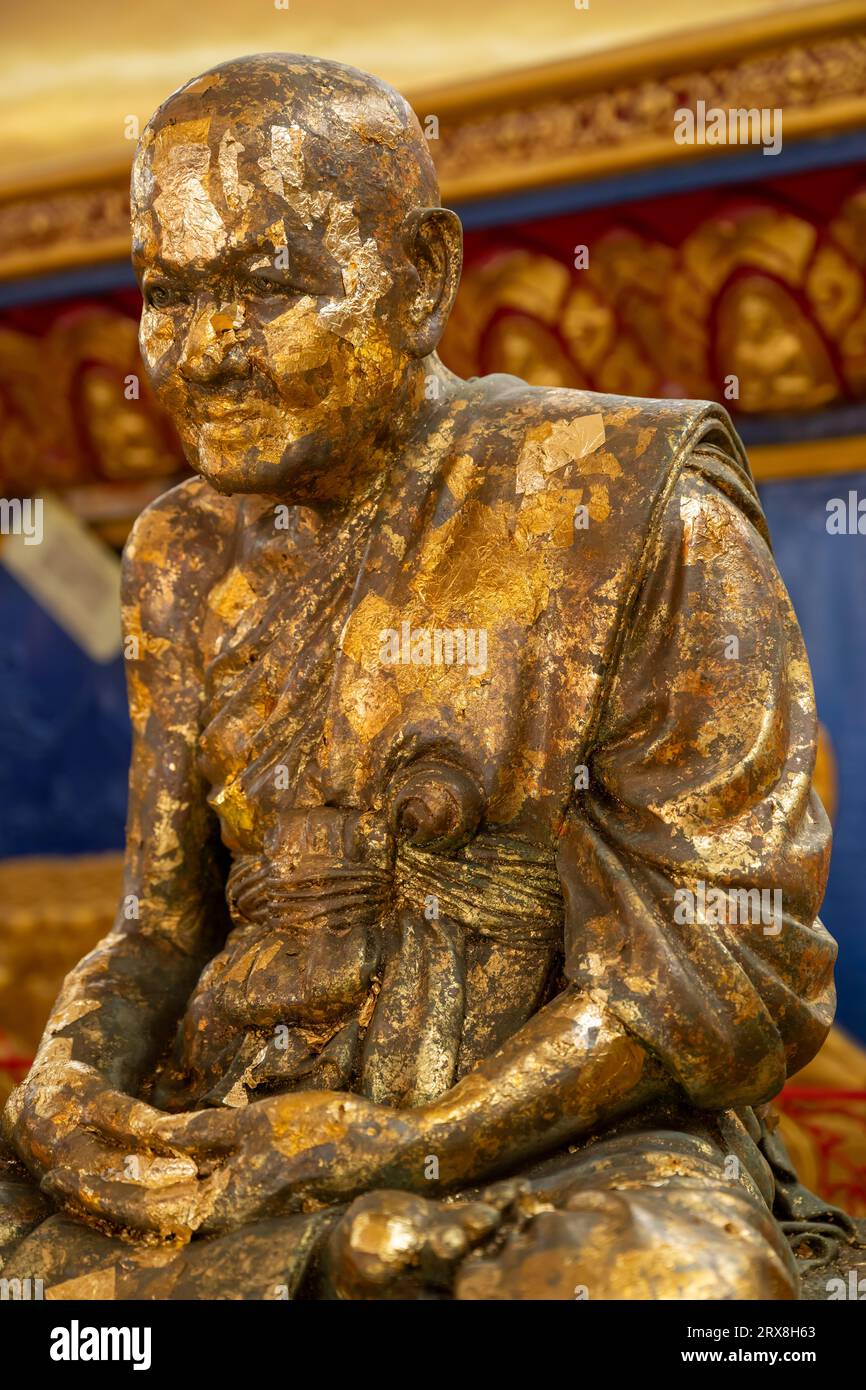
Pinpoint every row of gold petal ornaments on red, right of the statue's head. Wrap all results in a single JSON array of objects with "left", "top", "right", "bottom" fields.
[{"left": 442, "top": 195, "right": 866, "bottom": 414}]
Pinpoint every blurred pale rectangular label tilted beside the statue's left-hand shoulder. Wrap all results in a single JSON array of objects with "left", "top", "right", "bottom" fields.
[{"left": 0, "top": 496, "right": 121, "bottom": 662}]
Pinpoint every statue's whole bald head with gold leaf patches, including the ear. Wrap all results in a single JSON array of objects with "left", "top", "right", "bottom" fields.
[{"left": 132, "top": 53, "right": 460, "bottom": 491}]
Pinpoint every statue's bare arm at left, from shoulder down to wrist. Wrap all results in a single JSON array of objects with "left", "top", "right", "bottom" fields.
[{"left": 4, "top": 493, "right": 233, "bottom": 1175}]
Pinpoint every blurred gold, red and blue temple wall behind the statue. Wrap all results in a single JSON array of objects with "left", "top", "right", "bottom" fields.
[{"left": 0, "top": 0, "right": 866, "bottom": 1212}]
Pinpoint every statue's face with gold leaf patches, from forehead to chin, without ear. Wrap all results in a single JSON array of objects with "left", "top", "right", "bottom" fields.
[{"left": 133, "top": 115, "right": 411, "bottom": 496}]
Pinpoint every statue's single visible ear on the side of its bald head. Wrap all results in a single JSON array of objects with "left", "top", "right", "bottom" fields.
[{"left": 403, "top": 207, "right": 463, "bottom": 357}]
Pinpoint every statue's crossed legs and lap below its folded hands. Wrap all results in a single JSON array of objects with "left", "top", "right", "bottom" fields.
[{"left": 0, "top": 1112, "right": 798, "bottom": 1300}]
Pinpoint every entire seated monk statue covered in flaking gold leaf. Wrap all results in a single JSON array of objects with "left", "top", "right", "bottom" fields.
[{"left": 3, "top": 54, "right": 834, "bottom": 1298}]
